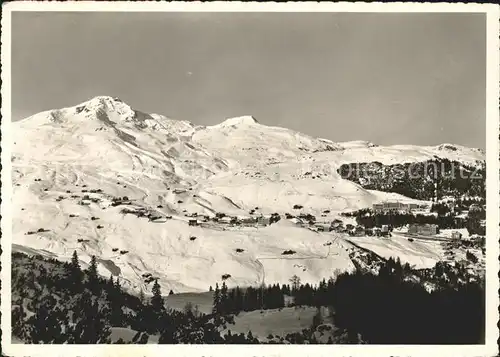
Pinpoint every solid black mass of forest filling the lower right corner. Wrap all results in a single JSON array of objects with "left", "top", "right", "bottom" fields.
[{"left": 331, "top": 262, "right": 485, "bottom": 344}]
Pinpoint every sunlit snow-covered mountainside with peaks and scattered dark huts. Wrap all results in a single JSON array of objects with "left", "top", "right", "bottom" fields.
[{"left": 12, "top": 96, "right": 485, "bottom": 293}]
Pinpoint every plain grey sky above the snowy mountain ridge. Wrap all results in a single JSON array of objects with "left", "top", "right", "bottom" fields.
[{"left": 12, "top": 12, "right": 486, "bottom": 149}]
